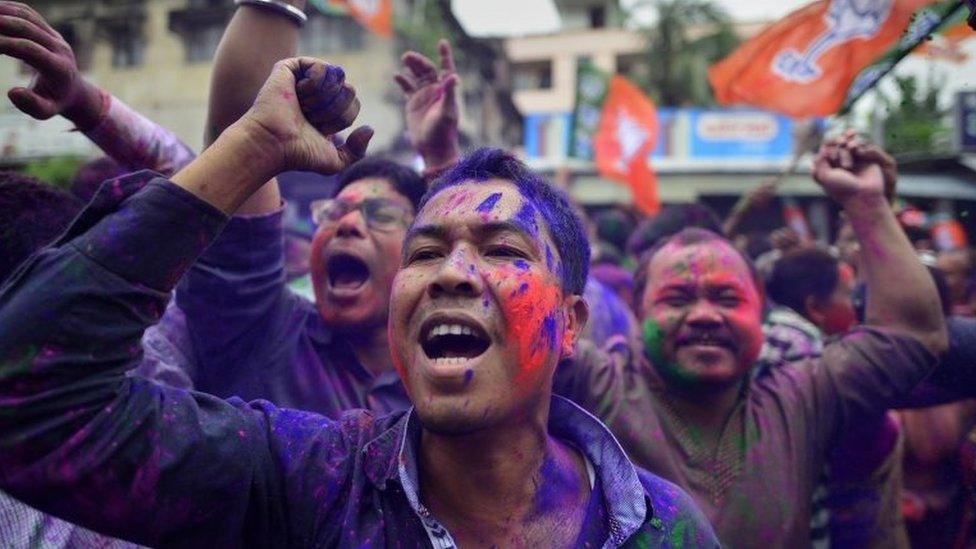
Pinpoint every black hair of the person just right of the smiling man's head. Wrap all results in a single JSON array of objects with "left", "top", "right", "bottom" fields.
[{"left": 766, "top": 248, "right": 840, "bottom": 316}]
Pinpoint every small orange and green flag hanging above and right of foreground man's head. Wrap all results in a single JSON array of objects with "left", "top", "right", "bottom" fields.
[{"left": 570, "top": 63, "right": 661, "bottom": 215}]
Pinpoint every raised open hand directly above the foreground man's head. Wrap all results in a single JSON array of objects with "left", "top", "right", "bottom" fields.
[{"left": 394, "top": 39, "right": 460, "bottom": 170}]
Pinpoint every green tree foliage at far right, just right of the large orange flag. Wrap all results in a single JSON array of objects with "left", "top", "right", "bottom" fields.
[{"left": 879, "top": 76, "right": 949, "bottom": 155}]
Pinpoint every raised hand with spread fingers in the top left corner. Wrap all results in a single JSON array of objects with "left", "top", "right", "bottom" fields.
[{"left": 0, "top": 1, "right": 103, "bottom": 130}]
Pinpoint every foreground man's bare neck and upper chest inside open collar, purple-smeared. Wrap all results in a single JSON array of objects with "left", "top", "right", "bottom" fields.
[{"left": 420, "top": 402, "right": 590, "bottom": 545}]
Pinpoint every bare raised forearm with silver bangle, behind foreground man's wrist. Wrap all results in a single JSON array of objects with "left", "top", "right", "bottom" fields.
[{"left": 204, "top": 0, "right": 305, "bottom": 214}]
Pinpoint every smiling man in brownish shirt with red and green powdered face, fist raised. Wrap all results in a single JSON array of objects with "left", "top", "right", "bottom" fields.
[{"left": 556, "top": 133, "right": 946, "bottom": 547}]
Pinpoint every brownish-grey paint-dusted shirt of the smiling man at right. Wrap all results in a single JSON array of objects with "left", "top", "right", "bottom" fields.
[{"left": 554, "top": 318, "right": 935, "bottom": 547}]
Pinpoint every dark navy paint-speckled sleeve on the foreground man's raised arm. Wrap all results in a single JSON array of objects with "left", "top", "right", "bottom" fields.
[{"left": 0, "top": 174, "right": 348, "bottom": 547}]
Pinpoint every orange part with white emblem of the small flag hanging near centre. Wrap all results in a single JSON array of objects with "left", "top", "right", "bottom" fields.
[{"left": 593, "top": 75, "right": 661, "bottom": 215}]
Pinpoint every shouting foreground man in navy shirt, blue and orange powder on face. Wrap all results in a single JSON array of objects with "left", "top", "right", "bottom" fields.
[{"left": 0, "top": 59, "right": 717, "bottom": 547}]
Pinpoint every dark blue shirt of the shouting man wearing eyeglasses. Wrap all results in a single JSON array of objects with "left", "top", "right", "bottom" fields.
[{"left": 143, "top": 203, "right": 410, "bottom": 418}]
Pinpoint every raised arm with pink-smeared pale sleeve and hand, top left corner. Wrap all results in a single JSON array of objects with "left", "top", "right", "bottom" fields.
[{"left": 0, "top": 2, "right": 195, "bottom": 175}]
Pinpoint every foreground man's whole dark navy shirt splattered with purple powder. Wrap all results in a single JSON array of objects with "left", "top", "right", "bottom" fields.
[{"left": 0, "top": 174, "right": 717, "bottom": 547}]
